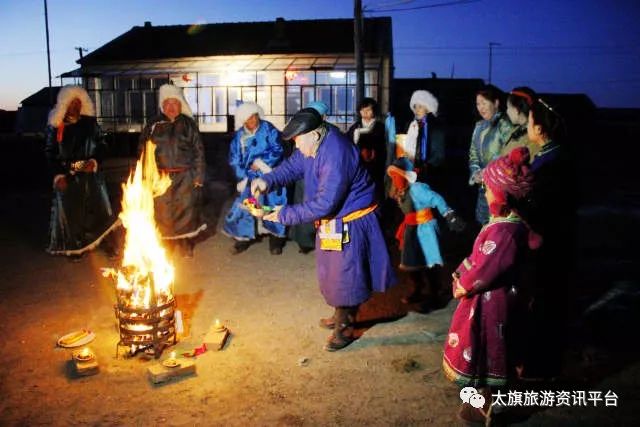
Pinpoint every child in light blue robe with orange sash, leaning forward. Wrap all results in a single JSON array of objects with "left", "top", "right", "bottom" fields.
[{"left": 387, "top": 157, "right": 465, "bottom": 308}]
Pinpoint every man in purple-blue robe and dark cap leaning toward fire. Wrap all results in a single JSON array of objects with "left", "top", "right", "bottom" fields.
[{"left": 251, "top": 108, "right": 395, "bottom": 351}]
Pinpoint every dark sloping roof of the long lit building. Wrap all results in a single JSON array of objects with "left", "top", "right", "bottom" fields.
[{"left": 77, "top": 17, "right": 393, "bottom": 68}]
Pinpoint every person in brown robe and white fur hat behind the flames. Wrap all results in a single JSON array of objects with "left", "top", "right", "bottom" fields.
[{"left": 140, "top": 84, "right": 207, "bottom": 258}]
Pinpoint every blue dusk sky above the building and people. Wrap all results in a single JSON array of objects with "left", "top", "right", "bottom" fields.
[{"left": 0, "top": 0, "right": 640, "bottom": 109}]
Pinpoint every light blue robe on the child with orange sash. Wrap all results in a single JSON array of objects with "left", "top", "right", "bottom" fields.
[{"left": 409, "top": 182, "right": 450, "bottom": 267}]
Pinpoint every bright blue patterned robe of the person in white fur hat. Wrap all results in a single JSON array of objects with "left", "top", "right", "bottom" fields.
[{"left": 223, "top": 120, "right": 287, "bottom": 241}]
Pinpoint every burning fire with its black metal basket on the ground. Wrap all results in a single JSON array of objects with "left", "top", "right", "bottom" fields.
[{"left": 103, "top": 141, "right": 177, "bottom": 358}]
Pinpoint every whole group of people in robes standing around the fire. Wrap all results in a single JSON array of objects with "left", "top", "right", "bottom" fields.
[{"left": 46, "top": 85, "right": 570, "bottom": 419}]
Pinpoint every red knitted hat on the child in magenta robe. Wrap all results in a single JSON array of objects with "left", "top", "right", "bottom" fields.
[{"left": 482, "top": 147, "right": 533, "bottom": 204}]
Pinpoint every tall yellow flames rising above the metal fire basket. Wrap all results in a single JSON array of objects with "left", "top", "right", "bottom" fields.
[{"left": 103, "top": 140, "right": 174, "bottom": 308}]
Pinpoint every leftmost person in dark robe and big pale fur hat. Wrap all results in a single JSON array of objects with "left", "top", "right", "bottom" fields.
[{"left": 45, "top": 86, "right": 118, "bottom": 261}]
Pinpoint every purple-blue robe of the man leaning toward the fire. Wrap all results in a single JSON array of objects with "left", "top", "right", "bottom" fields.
[{"left": 263, "top": 127, "right": 396, "bottom": 307}]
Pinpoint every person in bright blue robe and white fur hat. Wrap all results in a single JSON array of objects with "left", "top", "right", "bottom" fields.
[{"left": 222, "top": 102, "right": 287, "bottom": 255}]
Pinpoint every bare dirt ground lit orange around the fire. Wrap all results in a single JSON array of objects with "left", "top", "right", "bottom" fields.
[{"left": 0, "top": 187, "right": 640, "bottom": 426}]
